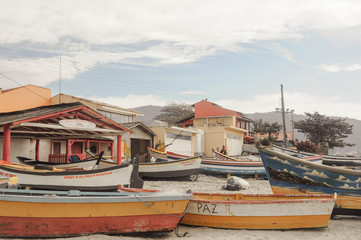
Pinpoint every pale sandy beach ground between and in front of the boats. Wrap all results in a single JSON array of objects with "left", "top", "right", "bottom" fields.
[{"left": 15, "top": 174, "right": 361, "bottom": 240}]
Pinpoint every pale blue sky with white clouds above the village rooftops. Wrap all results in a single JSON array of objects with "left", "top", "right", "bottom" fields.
[{"left": 0, "top": 0, "right": 361, "bottom": 120}]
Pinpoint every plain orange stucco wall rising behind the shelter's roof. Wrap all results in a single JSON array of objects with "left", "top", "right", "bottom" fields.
[{"left": 0, "top": 85, "right": 51, "bottom": 112}]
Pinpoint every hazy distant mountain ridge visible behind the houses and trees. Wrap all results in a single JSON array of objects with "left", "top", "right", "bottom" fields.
[{"left": 132, "top": 105, "right": 361, "bottom": 155}]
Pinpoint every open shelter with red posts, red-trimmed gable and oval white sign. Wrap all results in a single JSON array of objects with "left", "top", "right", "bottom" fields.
[{"left": 0, "top": 102, "right": 132, "bottom": 164}]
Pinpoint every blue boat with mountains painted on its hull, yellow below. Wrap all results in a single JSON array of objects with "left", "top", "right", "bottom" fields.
[{"left": 258, "top": 146, "right": 361, "bottom": 215}]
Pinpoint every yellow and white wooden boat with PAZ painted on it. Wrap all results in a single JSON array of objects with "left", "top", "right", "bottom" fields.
[{"left": 181, "top": 193, "right": 336, "bottom": 229}]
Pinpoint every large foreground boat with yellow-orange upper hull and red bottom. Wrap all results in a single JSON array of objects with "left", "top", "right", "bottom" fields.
[{"left": 0, "top": 189, "right": 191, "bottom": 238}]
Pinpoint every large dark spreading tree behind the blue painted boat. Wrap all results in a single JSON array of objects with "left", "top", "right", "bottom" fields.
[{"left": 294, "top": 112, "right": 354, "bottom": 149}]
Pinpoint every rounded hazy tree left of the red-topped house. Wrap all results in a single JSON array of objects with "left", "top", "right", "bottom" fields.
[{"left": 153, "top": 102, "right": 193, "bottom": 124}]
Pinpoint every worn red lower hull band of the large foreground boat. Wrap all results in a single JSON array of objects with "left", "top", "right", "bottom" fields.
[{"left": 0, "top": 214, "right": 181, "bottom": 237}]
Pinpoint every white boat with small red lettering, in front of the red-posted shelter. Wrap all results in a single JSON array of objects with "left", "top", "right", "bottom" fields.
[{"left": 0, "top": 154, "right": 133, "bottom": 191}]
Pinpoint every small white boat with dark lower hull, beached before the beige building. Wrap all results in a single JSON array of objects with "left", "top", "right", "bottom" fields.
[{"left": 100, "top": 156, "right": 202, "bottom": 181}]
